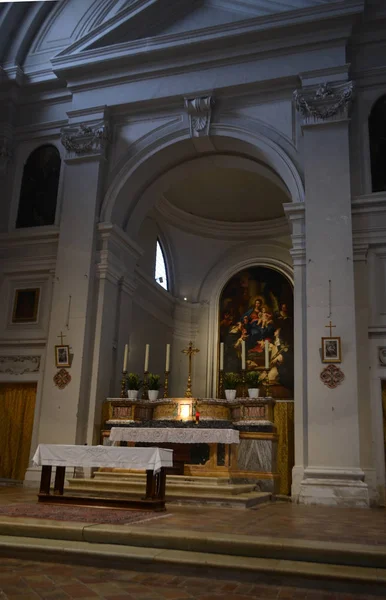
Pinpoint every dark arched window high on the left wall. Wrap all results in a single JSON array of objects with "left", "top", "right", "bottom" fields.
[{"left": 16, "top": 144, "right": 60, "bottom": 228}]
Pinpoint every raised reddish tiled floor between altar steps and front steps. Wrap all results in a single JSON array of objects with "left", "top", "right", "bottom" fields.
[{"left": 0, "top": 487, "right": 386, "bottom": 546}]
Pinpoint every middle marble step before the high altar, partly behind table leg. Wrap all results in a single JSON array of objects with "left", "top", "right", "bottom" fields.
[{"left": 67, "top": 478, "right": 256, "bottom": 496}]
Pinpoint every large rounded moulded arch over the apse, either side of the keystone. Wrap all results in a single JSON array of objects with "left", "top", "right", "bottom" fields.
[{"left": 101, "top": 116, "right": 304, "bottom": 235}]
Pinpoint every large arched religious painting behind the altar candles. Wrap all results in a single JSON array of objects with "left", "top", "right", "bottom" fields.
[{"left": 219, "top": 266, "right": 294, "bottom": 399}]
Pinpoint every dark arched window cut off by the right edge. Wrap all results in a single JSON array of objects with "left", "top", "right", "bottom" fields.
[{"left": 369, "top": 96, "right": 386, "bottom": 192}]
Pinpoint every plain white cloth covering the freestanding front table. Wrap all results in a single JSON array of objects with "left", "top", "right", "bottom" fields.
[{"left": 32, "top": 444, "right": 173, "bottom": 473}]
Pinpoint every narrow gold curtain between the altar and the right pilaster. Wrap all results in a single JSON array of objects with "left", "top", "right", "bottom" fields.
[{"left": 274, "top": 401, "right": 295, "bottom": 496}]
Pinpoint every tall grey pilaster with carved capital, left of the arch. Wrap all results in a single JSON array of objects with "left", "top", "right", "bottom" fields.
[{"left": 38, "top": 112, "right": 108, "bottom": 444}]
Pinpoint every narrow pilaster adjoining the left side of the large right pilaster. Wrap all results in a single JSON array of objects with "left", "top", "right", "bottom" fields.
[{"left": 284, "top": 202, "right": 308, "bottom": 500}]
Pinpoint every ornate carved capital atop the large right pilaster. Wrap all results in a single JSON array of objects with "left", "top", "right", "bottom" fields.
[{"left": 294, "top": 81, "right": 354, "bottom": 125}]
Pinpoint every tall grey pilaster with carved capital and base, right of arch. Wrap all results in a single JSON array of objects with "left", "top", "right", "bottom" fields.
[{"left": 295, "top": 75, "right": 369, "bottom": 506}]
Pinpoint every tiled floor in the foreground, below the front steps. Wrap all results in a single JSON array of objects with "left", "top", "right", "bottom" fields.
[{"left": 0, "top": 559, "right": 385, "bottom": 600}]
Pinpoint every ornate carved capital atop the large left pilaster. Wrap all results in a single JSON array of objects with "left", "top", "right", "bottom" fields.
[{"left": 61, "top": 121, "right": 108, "bottom": 156}]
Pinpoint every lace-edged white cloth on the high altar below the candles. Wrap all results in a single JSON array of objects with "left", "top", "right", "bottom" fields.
[{"left": 110, "top": 427, "right": 240, "bottom": 444}]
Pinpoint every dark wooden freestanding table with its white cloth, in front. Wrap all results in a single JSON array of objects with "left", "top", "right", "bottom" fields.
[{"left": 32, "top": 444, "right": 173, "bottom": 511}]
